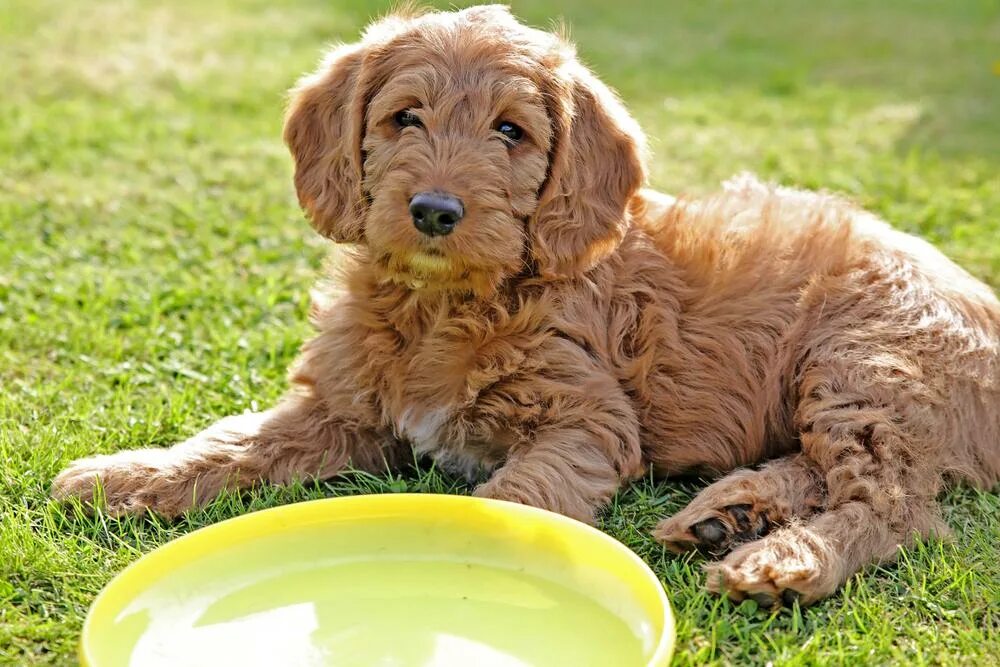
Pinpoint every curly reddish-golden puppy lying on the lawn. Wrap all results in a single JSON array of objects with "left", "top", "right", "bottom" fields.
[{"left": 54, "top": 7, "right": 1000, "bottom": 605}]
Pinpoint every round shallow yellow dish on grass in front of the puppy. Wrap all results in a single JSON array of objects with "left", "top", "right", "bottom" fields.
[{"left": 80, "top": 494, "right": 674, "bottom": 667}]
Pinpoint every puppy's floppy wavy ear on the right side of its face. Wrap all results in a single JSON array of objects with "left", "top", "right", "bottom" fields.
[{"left": 528, "top": 60, "right": 645, "bottom": 278}]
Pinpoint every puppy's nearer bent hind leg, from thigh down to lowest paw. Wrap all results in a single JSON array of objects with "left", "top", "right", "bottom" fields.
[{"left": 708, "top": 351, "right": 947, "bottom": 606}]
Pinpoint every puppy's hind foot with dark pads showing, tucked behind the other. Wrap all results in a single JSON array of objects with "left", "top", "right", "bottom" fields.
[{"left": 653, "top": 454, "right": 826, "bottom": 556}]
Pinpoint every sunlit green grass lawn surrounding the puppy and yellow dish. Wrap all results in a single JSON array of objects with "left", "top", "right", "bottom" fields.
[{"left": 0, "top": 0, "right": 1000, "bottom": 665}]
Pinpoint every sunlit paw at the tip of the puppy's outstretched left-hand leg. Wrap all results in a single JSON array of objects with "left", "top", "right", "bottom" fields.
[{"left": 52, "top": 449, "right": 186, "bottom": 517}]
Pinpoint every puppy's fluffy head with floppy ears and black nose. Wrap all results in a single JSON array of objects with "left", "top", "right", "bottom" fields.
[{"left": 285, "top": 6, "right": 644, "bottom": 292}]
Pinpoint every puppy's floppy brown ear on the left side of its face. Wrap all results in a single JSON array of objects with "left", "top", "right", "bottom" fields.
[{"left": 285, "top": 44, "right": 367, "bottom": 242}]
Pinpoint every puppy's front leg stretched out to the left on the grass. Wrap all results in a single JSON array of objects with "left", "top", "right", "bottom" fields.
[{"left": 52, "top": 395, "right": 398, "bottom": 517}]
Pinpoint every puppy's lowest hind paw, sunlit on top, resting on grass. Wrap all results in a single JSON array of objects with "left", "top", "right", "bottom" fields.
[{"left": 705, "top": 526, "right": 843, "bottom": 609}]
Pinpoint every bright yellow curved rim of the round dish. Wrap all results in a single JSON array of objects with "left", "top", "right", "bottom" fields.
[{"left": 77, "top": 493, "right": 676, "bottom": 667}]
